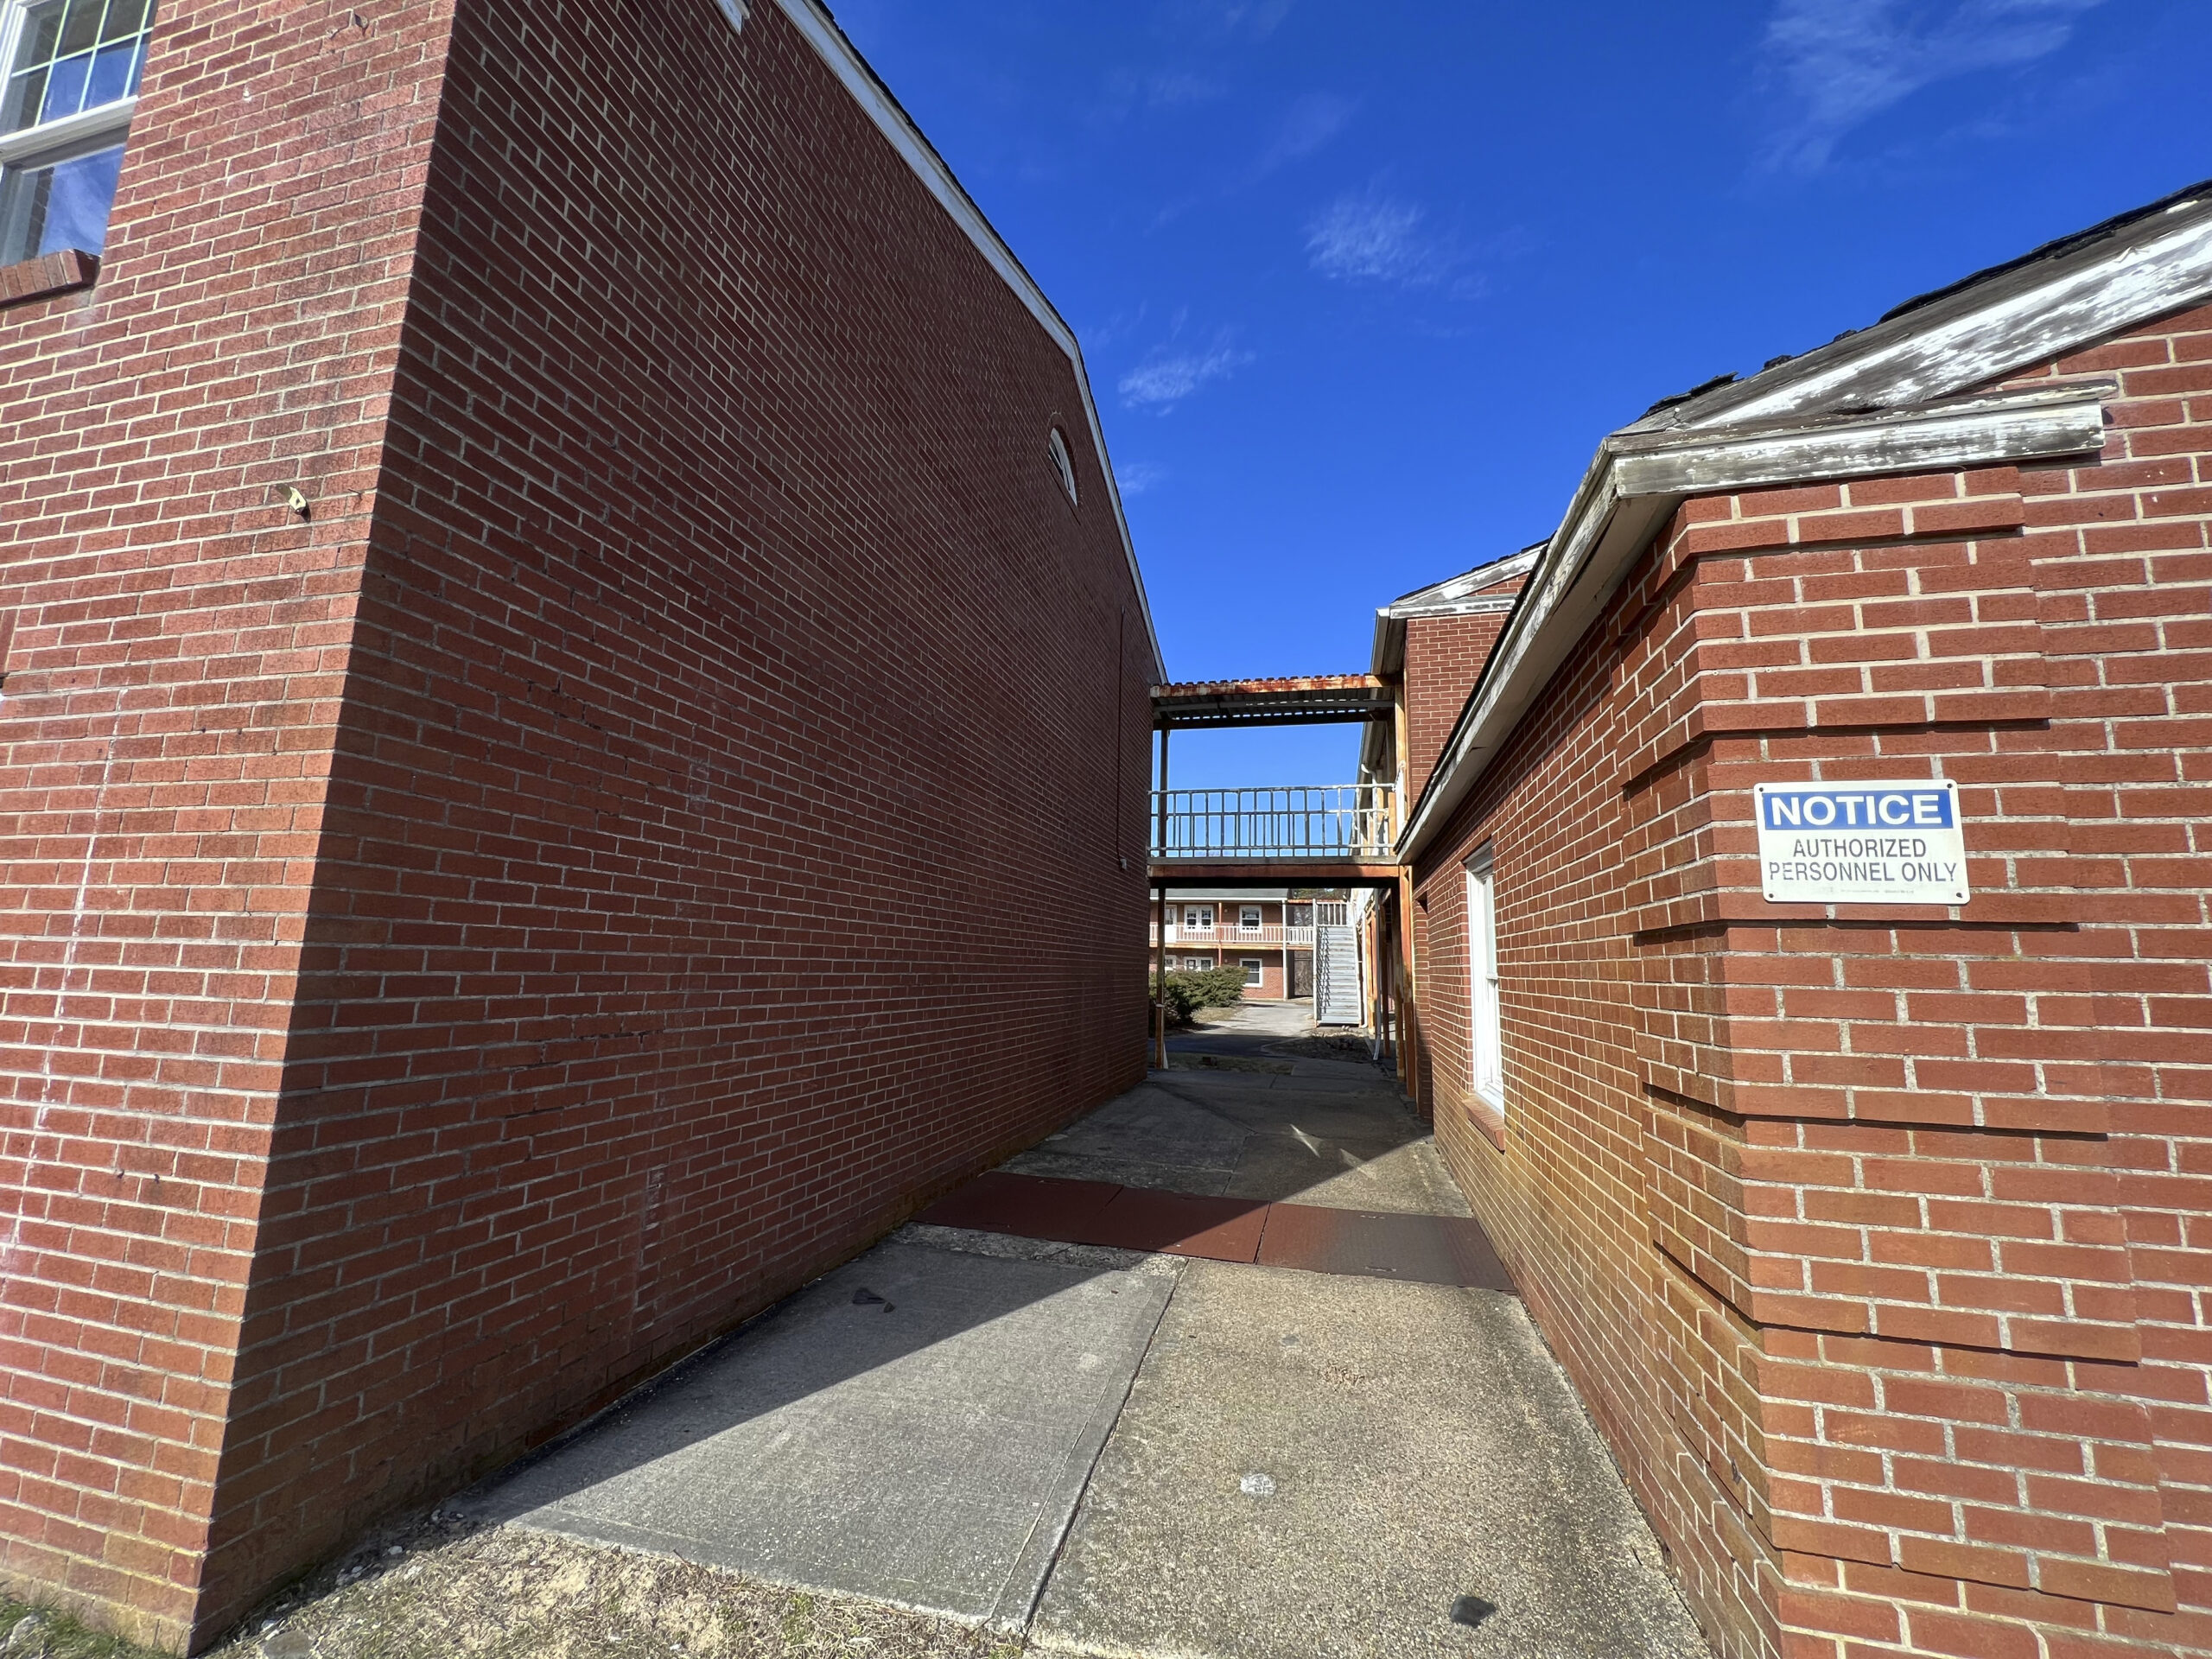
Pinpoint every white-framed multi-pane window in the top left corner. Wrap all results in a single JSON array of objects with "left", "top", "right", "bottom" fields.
[{"left": 0, "top": 0, "right": 153, "bottom": 265}]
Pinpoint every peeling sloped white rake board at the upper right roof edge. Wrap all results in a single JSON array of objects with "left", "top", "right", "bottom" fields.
[{"left": 1683, "top": 201, "right": 2212, "bottom": 429}]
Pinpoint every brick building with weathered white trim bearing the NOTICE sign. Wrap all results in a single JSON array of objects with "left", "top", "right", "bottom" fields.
[{"left": 1370, "top": 186, "right": 2212, "bottom": 1659}]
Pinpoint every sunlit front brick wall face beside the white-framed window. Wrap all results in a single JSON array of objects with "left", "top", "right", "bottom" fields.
[{"left": 0, "top": 0, "right": 449, "bottom": 1642}]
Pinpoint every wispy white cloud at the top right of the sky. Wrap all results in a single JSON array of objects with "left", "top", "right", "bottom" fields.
[{"left": 1761, "top": 0, "right": 2104, "bottom": 173}]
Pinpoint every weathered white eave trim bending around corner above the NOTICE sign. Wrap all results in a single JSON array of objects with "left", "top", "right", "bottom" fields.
[{"left": 1398, "top": 380, "right": 2114, "bottom": 862}]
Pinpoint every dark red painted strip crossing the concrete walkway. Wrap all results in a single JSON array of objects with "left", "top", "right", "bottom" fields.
[{"left": 916, "top": 1170, "right": 1513, "bottom": 1292}]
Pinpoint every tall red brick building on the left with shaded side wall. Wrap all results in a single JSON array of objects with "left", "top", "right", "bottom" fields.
[{"left": 0, "top": 0, "right": 1164, "bottom": 1646}]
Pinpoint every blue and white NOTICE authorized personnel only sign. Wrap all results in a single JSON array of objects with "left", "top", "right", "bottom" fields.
[{"left": 1752, "top": 779, "right": 1968, "bottom": 905}]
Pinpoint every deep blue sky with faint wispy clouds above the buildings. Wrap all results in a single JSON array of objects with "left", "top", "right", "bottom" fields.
[{"left": 836, "top": 0, "right": 2212, "bottom": 787}]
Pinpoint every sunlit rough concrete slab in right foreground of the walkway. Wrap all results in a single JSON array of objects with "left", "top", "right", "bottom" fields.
[{"left": 1031, "top": 1261, "right": 1706, "bottom": 1659}]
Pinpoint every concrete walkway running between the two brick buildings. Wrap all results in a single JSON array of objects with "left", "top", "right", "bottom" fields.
[{"left": 467, "top": 1007, "right": 1706, "bottom": 1659}]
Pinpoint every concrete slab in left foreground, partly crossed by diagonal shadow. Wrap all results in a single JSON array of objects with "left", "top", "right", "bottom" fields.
[{"left": 465, "top": 1243, "right": 1173, "bottom": 1628}]
